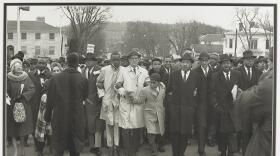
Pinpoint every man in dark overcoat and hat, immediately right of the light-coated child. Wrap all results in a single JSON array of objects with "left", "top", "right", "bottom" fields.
[{"left": 167, "top": 53, "right": 206, "bottom": 156}]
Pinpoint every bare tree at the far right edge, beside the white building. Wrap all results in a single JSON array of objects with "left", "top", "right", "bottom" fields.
[{"left": 258, "top": 12, "right": 273, "bottom": 47}]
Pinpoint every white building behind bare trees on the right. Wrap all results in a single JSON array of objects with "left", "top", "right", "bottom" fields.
[{"left": 223, "top": 28, "right": 273, "bottom": 57}]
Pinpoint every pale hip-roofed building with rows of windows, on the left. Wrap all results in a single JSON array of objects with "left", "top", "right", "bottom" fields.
[{"left": 6, "top": 17, "right": 67, "bottom": 59}]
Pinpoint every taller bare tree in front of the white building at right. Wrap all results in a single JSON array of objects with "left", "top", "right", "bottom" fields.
[{"left": 235, "top": 8, "right": 259, "bottom": 50}]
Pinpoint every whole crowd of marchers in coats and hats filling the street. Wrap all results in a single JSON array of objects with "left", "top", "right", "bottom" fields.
[{"left": 6, "top": 49, "right": 274, "bottom": 156}]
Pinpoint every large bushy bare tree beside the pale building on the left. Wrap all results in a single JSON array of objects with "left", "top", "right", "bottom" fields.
[{"left": 60, "top": 5, "right": 110, "bottom": 53}]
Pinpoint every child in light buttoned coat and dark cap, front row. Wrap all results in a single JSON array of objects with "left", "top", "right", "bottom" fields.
[{"left": 133, "top": 73, "right": 165, "bottom": 155}]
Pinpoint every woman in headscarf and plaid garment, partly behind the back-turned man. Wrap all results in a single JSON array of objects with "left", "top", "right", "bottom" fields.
[{"left": 35, "top": 62, "right": 62, "bottom": 156}]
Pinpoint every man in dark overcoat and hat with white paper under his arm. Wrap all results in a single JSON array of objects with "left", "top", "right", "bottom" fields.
[{"left": 210, "top": 54, "right": 241, "bottom": 156}]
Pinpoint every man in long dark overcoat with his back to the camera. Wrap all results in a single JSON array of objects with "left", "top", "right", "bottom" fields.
[{"left": 45, "top": 53, "right": 88, "bottom": 156}]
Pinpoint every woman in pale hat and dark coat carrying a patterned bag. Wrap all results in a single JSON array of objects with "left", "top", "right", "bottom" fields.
[{"left": 7, "top": 59, "right": 35, "bottom": 156}]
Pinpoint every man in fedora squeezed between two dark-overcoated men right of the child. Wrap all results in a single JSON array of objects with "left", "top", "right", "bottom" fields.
[{"left": 194, "top": 52, "right": 219, "bottom": 156}]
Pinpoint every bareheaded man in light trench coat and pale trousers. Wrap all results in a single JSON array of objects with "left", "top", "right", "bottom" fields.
[{"left": 96, "top": 52, "right": 122, "bottom": 156}]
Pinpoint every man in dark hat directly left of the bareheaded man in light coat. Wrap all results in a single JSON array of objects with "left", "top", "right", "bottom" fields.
[{"left": 82, "top": 53, "right": 105, "bottom": 155}]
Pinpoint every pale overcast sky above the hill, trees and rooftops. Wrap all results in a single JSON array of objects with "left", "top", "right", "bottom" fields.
[{"left": 7, "top": 6, "right": 273, "bottom": 30}]
